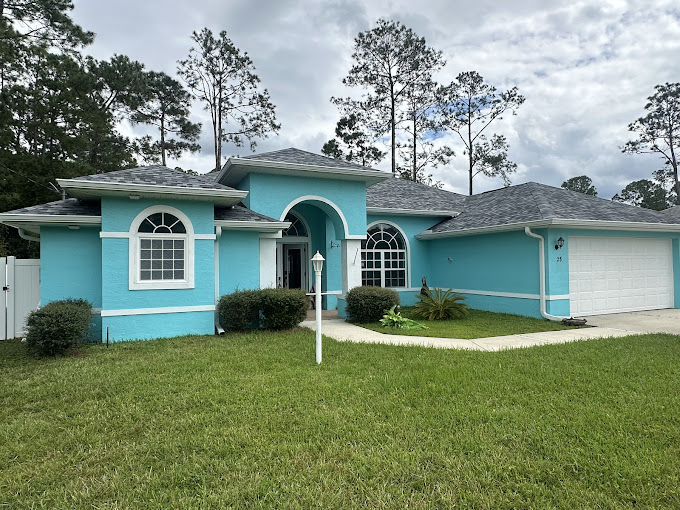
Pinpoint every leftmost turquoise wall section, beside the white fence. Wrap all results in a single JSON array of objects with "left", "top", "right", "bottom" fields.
[{"left": 40, "top": 226, "right": 102, "bottom": 308}]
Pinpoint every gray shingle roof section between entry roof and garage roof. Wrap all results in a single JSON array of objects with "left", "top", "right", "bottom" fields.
[{"left": 366, "top": 179, "right": 466, "bottom": 212}]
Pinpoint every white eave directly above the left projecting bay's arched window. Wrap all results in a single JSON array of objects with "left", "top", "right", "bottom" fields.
[{"left": 57, "top": 179, "right": 248, "bottom": 205}]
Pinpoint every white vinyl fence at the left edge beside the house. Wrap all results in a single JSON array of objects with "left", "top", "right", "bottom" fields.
[{"left": 0, "top": 257, "right": 40, "bottom": 340}]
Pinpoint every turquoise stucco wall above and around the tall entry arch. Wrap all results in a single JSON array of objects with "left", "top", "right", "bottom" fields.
[{"left": 238, "top": 173, "right": 366, "bottom": 238}]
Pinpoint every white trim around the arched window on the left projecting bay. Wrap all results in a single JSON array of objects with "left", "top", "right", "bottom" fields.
[{"left": 128, "top": 205, "right": 195, "bottom": 290}]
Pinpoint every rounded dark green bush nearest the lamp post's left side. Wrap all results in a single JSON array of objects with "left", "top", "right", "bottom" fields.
[{"left": 260, "top": 289, "right": 309, "bottom": 330}]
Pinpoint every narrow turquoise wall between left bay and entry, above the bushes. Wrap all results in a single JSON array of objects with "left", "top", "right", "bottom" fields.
[{"left": 218, "top": 230, "right": 260, "bottom": 296}]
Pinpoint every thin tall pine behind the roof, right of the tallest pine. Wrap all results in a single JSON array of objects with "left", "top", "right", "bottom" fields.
[{"left": 439, "top": 71, "right": 524, "bottom": 195}]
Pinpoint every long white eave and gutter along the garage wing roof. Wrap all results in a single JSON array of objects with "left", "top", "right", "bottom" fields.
[{"left": 416, "top": 218, "right": 680, "bottom": 240}]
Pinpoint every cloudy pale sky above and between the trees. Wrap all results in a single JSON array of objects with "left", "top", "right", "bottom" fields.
[{"left": 73, "top": 0, "right": 680, "bottom": 198}]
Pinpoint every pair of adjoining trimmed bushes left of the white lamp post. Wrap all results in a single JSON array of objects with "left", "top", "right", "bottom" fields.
[{"left": 218, "top": 289, "right": 309, "bottom": 331}]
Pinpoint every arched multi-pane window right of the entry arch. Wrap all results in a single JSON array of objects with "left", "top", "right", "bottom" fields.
[{"left": 361, "top": 223, "right": 407, "bottom": 287}]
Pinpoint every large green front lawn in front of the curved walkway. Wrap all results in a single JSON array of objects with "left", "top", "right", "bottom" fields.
[{"left": 0, "top": 330, "right": 680, "bottom": 509}]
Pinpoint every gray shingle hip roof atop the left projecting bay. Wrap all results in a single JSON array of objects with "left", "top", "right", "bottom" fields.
[{"left": 77, "top": 165, "right": 238, "bottom": 190}]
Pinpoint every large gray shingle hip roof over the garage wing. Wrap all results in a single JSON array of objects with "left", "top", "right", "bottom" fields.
[{"left": 430, "top": 182, "right": 680, "bottom": 232}]
